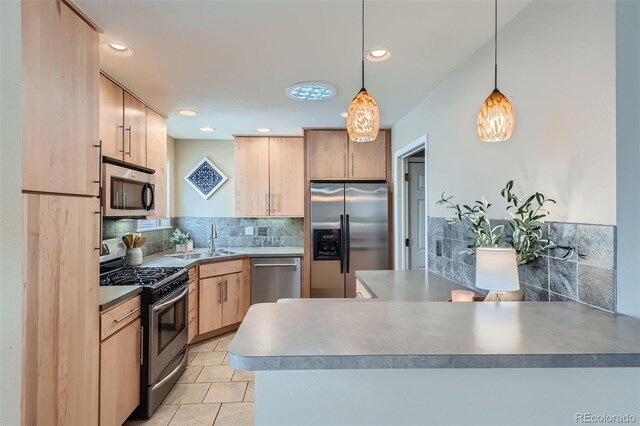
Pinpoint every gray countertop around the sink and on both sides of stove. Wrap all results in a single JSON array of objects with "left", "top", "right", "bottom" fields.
[{"left": 100, "top": 247, "right": 304, "bottom": 312}]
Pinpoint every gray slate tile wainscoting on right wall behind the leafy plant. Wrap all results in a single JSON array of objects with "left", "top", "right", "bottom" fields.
[{"left": 427, "top": 217, "right": 616, "bottom": 312}]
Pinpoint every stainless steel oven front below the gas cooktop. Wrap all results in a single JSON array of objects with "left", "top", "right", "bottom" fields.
[{"left": 147, "top": 281, "right": 189, "bottom": 416}]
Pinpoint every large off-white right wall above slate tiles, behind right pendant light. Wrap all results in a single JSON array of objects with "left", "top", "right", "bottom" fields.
[{"left": 393, "top": 1, "right": 616, "bottom": 224}]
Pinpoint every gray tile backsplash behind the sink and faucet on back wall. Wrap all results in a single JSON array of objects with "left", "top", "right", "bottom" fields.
[{"left": 171, "top": 217, "right": 304, "bottom": 247}]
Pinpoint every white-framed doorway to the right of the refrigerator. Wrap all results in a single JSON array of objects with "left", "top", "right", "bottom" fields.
[{"left": 393, "top": 135, "right": 428, "bottom": 270}]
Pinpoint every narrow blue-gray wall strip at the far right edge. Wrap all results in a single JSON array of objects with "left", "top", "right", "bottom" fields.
[{"left": 616, "top": 0, "right": 640, "bottom": 318}]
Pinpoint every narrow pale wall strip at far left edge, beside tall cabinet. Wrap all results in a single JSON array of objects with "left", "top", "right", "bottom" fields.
[{"left": 0, "top": 1, "right": 22, "bottom": 425}]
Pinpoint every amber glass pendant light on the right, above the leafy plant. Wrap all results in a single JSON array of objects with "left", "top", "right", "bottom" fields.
[{"left": 477, "top": 0, "right": 516, "bottom": 142}]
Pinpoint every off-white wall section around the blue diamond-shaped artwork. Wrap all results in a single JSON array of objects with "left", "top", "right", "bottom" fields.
[{"left": 172, "top": 139, "right": 235, "bottom": 217}]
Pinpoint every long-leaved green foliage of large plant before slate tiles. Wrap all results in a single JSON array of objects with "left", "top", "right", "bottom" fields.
[{"left": 436, "top": 180, "right": 585, "bottom": 297}]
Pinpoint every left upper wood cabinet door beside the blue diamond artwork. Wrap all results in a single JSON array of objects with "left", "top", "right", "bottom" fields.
[{"left": 234, "top": 137, "right": 269, "bottom": 217}]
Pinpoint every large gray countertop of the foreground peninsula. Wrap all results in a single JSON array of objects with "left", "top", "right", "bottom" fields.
[{"left": 229, "top": 301, "right": 640, "bottom": 370}]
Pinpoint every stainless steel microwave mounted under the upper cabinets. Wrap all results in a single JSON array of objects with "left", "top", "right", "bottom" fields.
[{"left": 101, "top": 163, "right": 155, "bottom": 218}]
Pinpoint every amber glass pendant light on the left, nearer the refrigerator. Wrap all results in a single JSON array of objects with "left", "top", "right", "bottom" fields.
[{"left": 347, "top": 0, "right": 380, "bottom": 142}]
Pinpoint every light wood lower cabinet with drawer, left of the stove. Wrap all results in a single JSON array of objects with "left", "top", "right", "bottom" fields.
[{"left": 100, "top": 297, "right": 142, "bottom": 426}]
